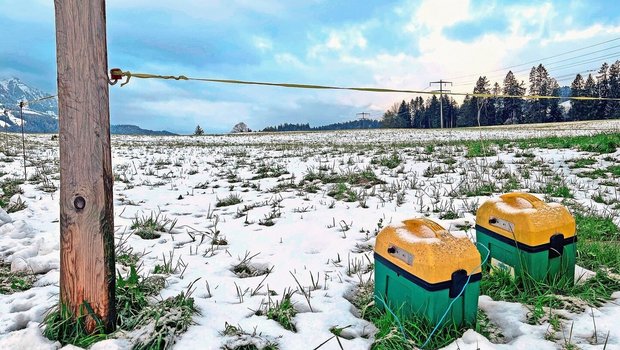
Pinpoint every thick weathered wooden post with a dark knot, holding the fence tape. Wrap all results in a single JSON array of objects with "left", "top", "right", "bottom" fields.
[{"left": 54, "top": 0, "right": 116, "bottom": 331}]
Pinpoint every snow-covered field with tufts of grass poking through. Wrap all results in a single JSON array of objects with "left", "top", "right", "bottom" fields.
[{"left": 0, "top": 121, "right": 620, "bottom": 349}]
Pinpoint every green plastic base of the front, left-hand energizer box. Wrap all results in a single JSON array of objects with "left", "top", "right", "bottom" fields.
[{"left": 375, "top": 260, "right": 480, "bottom": 326}]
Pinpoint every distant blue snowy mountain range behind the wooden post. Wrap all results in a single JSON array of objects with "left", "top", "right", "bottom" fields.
[{"left": 0, "top": 78, "right": 176, "bottom": 135}]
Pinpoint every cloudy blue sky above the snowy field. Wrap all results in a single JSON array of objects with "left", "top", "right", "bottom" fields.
[{"left": 0, "top": 0, "right": 620, "bottom": 133}]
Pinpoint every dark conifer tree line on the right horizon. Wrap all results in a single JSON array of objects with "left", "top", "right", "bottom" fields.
[{"left": 381, "top": 60, "right": 620, "bottom": 128}]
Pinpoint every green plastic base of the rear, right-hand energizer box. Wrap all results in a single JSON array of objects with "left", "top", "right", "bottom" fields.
[{"left": 476, "top": 231, "right": 577, "bottom": 282}]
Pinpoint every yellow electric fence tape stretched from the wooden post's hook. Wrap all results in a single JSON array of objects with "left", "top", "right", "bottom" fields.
[{"left": 112, "top": 69, "right": 620, "bottom": 101}]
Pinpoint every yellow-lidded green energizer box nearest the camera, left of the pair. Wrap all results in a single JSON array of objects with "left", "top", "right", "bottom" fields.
[{"left": 374, "top": 219, "right": 481, "bottom": 325}]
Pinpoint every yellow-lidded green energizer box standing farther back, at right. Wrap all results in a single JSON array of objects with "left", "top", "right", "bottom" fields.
[{"left": 476, "top": 192, "right": 577, "bottom": 281}]
